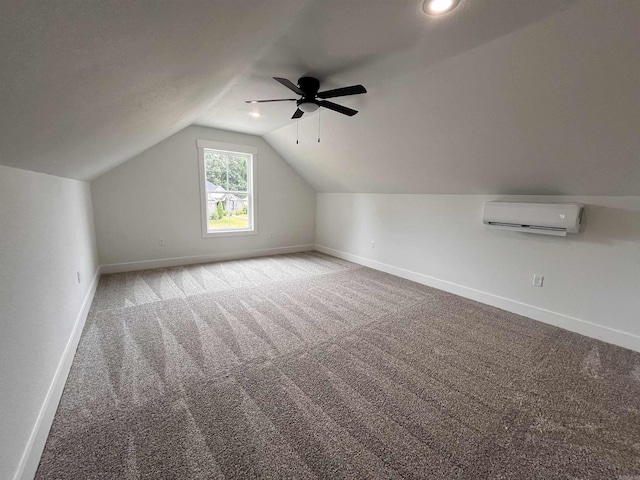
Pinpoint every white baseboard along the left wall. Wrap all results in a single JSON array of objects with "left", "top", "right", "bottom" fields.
[{"left": 13, "top": 267, "right": 101, "bottom": 480}]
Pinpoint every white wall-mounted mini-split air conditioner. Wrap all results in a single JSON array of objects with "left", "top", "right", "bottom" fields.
[{"left": 482, "top": 202, "right": 584, "bottom": 236}]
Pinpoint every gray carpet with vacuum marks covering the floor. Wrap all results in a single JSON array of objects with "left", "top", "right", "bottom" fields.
[{"left": 37, "top": 252, "right": 640, "bottom": 479}]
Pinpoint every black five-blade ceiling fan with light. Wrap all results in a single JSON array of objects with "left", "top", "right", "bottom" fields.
[{"left": 246, "top": 77, "right": 367, "bottom": 118}]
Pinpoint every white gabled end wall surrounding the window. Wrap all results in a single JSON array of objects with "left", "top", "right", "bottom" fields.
[{"left": 91, "top": 126, "right": 315, "bottom": 271}]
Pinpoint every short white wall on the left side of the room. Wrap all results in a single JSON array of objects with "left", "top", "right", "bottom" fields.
[{"left": 0, "top": 166, "right": 98, "bottom": 479}]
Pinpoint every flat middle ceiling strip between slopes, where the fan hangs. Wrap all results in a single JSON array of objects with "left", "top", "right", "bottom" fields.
[{"left": 196, "top": 0, "right": 578, "bottom": 135}]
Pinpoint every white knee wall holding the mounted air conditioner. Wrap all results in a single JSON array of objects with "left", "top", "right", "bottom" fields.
[{"left": 316, "top": 193, "right": 640, "bottom": 350}]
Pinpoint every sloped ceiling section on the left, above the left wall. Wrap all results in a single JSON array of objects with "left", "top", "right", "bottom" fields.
[{"left": 0, "top": 0, "right": 305, "bottom": 180}]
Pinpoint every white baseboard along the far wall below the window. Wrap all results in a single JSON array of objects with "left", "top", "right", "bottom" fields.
[{"left": 101, "top": 245, "right": 314, "bottom": 274}]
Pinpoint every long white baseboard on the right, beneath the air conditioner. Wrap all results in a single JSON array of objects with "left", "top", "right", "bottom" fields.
[{"left": 315, "top": 245, "right": 640, "bottom": 352}]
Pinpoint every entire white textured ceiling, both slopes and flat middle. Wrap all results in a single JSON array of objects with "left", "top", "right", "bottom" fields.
[{"left": 0, "top": 0, "right": 640, "bottom": 195}]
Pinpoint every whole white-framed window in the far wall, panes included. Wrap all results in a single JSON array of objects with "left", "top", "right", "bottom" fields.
[{"left": 198, "top": 140, "right": 258, "bottom": 237}]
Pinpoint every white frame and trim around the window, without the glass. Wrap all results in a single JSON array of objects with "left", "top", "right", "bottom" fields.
[{"left": 196, "top": 140, "right": 258, "bottom": 238}]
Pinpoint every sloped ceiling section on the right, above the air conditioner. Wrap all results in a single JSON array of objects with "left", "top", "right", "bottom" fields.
[{"left": 265, "top": 1, "right": 640, "bottom": 195}]
